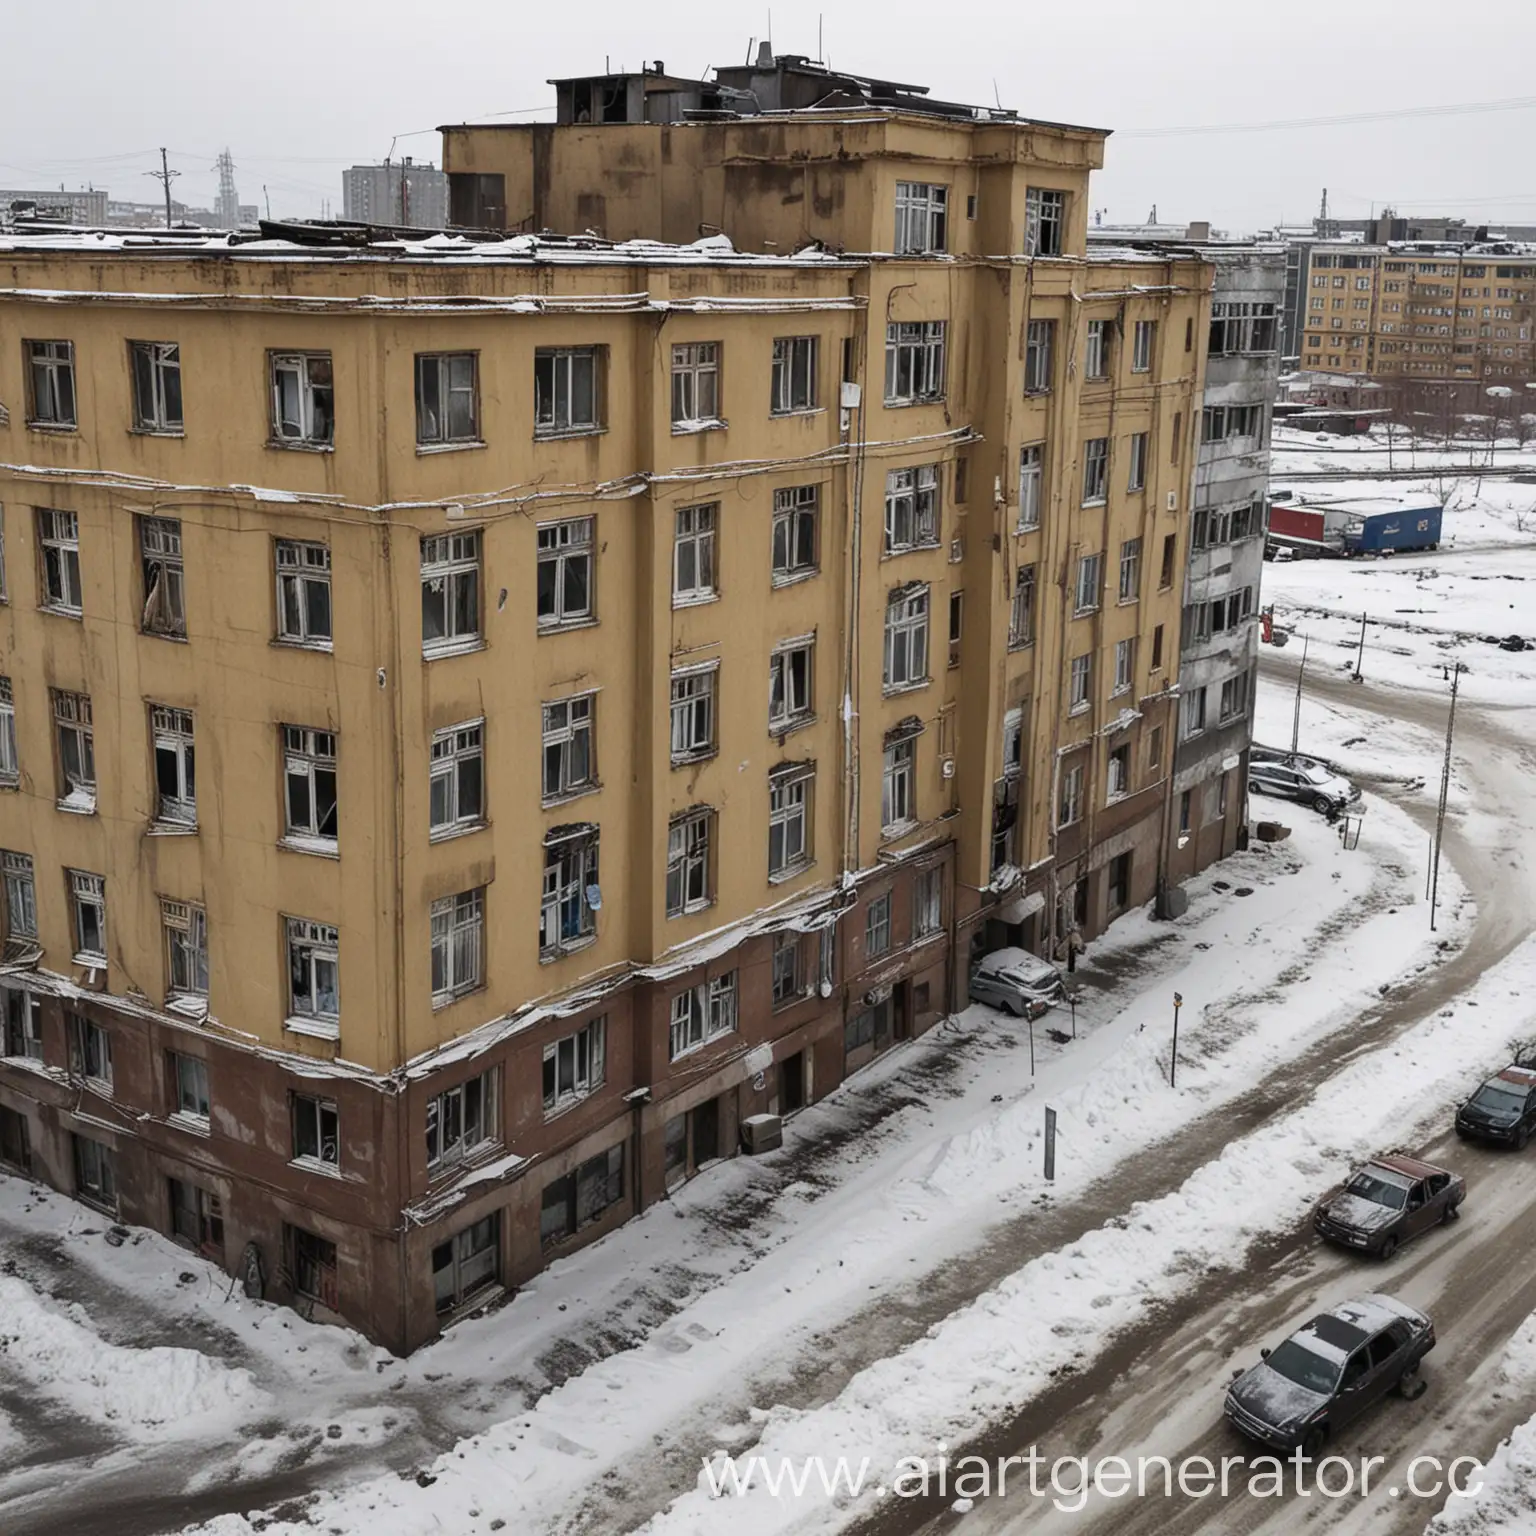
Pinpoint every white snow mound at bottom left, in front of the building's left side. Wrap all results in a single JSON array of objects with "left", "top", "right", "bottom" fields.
[{"left": 0, "top": 1275, "right": 266, "bottom": 1439}]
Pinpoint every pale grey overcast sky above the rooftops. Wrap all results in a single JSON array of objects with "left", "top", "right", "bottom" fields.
[{"left": 9, "top": 0, "right": 1536, "bottom": 229}]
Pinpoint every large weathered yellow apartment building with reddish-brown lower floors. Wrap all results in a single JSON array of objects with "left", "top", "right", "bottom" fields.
[{"left": 0, "top": 62, "right": 1210, "bottom": 1350}]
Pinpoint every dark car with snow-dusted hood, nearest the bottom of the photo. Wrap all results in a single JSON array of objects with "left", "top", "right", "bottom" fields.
[{"left": 1224, "top": 1296, "right": 1435, "bottom": 1456}]
